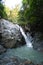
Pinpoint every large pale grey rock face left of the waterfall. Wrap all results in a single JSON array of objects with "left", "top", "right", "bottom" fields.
[{"left": 0, "top": 19, "right": 25, "bottom": 48}]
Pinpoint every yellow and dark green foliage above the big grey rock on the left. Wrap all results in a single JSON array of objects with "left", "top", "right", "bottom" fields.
[{"left": 0, "top": 2, "right": 19, "bottom": 22}]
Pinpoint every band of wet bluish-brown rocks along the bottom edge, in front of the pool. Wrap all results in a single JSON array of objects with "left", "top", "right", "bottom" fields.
[{"left": 0, "top": 56, "right": 43, "bottom": 65}]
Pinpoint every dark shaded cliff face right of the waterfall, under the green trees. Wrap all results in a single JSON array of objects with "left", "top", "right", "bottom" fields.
[{"left": 24, "top": 25, "right": 43, "bottom": 52}]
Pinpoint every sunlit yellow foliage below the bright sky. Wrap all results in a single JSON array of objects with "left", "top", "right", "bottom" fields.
[{"left": 4, "top": 5, "right": 19, "bottom": 23}]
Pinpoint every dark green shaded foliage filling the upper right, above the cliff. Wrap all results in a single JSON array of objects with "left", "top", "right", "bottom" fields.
[{"left": 20, "top": 0, "right": 43, "bottom": 30}]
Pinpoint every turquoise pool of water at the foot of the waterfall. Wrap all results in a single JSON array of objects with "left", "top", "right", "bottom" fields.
[{"left": 1, "top": 46, "right": 43, "bottom": 63}]
